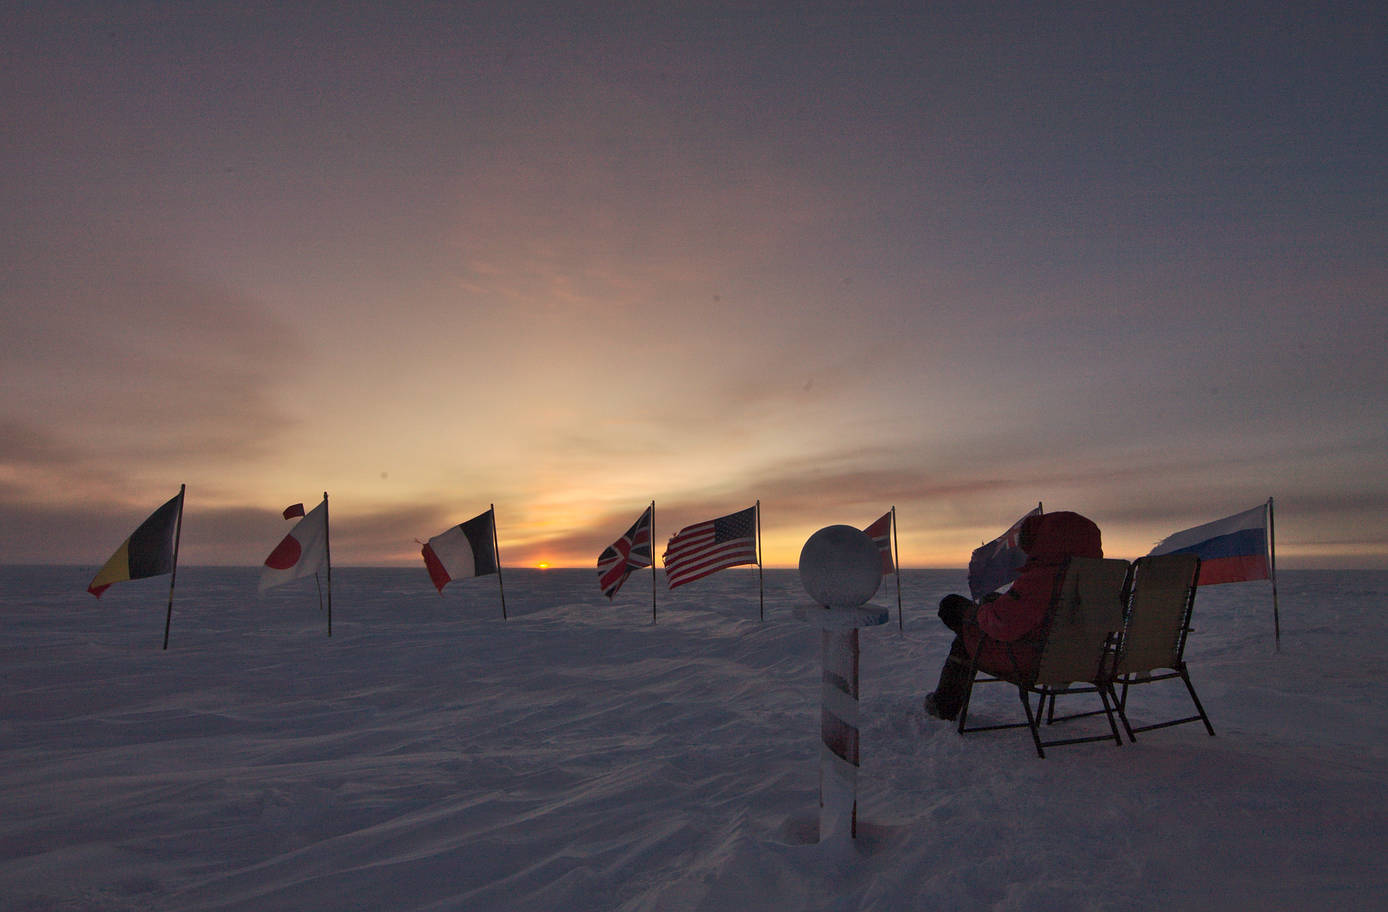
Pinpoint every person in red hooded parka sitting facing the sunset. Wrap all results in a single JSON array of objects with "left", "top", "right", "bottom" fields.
[{"left": 926, "top": 512, "right": 1103, "bottom": 719}]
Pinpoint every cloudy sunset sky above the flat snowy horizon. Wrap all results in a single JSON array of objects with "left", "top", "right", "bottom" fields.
[{"left": 0, "top": 0, "right": 1388, "bottom": 568}]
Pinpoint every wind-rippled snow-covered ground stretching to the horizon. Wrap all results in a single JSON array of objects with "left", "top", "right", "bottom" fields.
[{"left": 0, "top": 568, "right": 1388, "bottom": 912}]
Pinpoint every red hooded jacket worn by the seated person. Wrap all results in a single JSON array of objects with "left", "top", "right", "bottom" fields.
[{"left": 959, "top": 512, "right": 1103, "bottom": 677}]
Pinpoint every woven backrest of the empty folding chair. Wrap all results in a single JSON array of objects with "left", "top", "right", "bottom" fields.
[{"left": 1117, "top": 554, "right": 1201, "bottom": 675}]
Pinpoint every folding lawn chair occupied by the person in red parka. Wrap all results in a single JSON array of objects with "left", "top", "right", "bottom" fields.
[{"left": 959, "top": 558, "right": 1130, "bottom": 758}]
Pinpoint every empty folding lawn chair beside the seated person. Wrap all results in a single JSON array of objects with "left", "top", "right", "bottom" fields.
[{"left": 1113, "top": 554, "right": 1215, "bottom": 741}]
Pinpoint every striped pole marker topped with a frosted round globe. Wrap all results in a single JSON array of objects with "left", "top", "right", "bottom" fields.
[{"left": 795, "top": 526, "right": 888, "bottom": 841}]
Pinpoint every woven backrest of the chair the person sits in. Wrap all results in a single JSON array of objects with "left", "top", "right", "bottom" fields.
[{"left": 1034, "top": 558, "right": 1128, "bottom": 686}]
